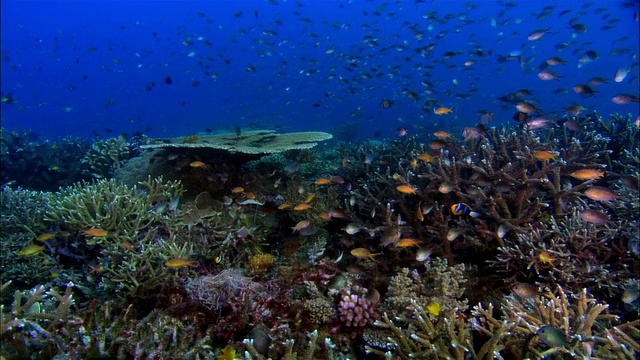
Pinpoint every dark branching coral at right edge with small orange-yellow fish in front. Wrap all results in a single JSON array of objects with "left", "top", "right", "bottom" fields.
[{"left": 490, "top": 209, "right": 640, "bottom": 297}]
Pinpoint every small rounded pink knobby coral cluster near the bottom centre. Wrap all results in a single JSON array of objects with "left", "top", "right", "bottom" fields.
[{"left": 338, "top": 285, "right": 380, "bottom": 327}]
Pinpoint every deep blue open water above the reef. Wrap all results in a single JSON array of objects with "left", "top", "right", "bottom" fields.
[{"left": 1, "top": 0, "right": 638, "bottom": 138}]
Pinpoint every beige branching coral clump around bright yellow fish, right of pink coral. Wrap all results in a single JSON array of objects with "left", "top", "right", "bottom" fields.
[{"left": 365, "top": 259, "right": 473, "bottom": 359}]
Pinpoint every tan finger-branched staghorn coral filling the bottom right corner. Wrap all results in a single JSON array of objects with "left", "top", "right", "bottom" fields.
[{"left": 470, "top": 286, "right": 640, "bottom": 359}]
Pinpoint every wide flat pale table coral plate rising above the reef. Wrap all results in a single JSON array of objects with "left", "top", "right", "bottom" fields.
[{"left": 141, "top": 130, "right": 333, "bottom": 155}]
